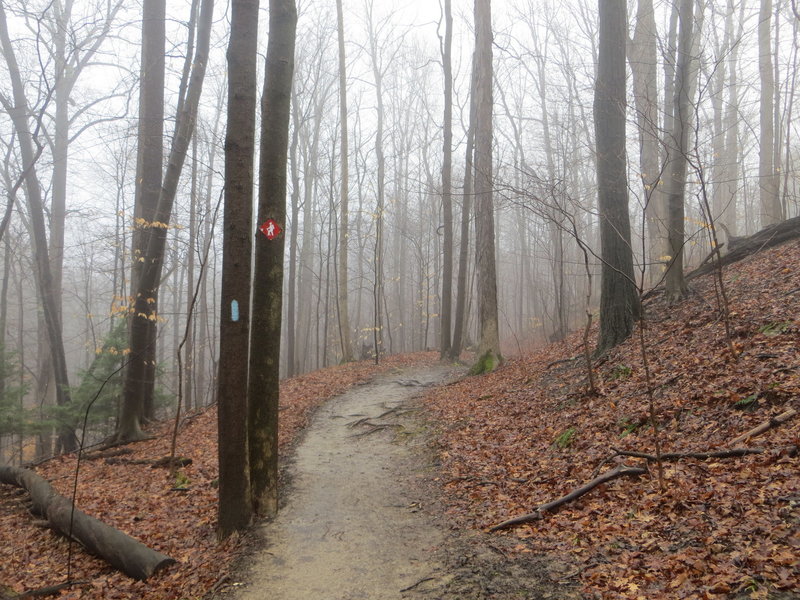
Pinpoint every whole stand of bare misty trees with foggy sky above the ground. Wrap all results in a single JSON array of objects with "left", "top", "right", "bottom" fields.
[{"left": 0, "top": 0, "right": 800, "bottom": 533}]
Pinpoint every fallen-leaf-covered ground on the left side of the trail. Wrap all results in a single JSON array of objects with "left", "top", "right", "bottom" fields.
[{"left": 0, "top": 353, "right": 438, "bottom": 600}]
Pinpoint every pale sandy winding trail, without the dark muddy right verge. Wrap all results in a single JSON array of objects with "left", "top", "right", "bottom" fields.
[{"left": 231, "top": 367, "right": 452, "bottom": 600}]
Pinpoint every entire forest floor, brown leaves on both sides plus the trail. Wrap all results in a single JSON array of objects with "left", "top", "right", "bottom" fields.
[{"left": 0, "top": 242, "right": 800, "bottom": 600}]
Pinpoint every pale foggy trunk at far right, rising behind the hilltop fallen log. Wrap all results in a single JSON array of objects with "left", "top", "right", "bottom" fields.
[{"left": 758, "top": 0, "right": 783, "bottom": 228}]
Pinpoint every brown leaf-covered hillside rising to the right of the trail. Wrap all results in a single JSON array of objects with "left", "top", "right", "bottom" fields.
[{"left": 428, "top": 242, "right": 800, "bottom": 600}]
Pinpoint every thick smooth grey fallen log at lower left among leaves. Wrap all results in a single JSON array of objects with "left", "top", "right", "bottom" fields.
[{"left": 0, "top": 466, "right": 176, "bottom": 580}]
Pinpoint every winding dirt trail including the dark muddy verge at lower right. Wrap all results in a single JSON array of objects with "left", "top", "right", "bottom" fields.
[{"left": 228, "top": 366, "right": 580, "bottom": 600}]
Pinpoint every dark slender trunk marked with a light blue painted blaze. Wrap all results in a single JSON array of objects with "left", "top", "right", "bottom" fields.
[{"left": 217, "top": 0, "right": 259, "bottom": 538}]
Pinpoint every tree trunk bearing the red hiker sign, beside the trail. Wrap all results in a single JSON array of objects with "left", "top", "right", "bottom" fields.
[{"left": 247, "top": 0, "right": 297, "bottom": 516}]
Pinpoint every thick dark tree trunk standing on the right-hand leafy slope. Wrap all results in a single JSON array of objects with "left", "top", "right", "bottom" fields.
[{"left": 594, "top": 0, "right": 639, "bottom": 352}]
